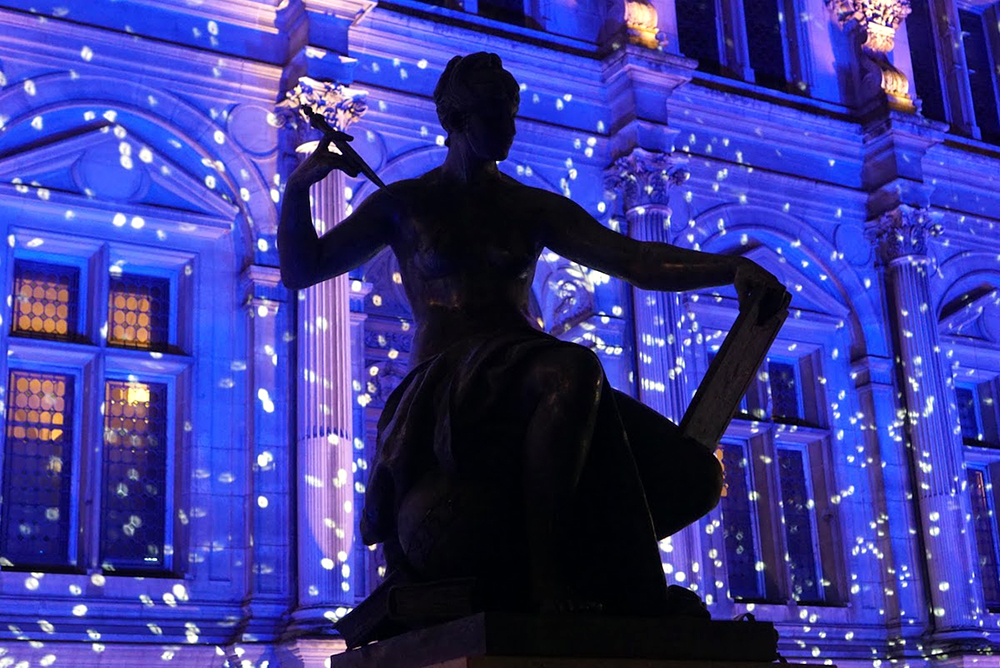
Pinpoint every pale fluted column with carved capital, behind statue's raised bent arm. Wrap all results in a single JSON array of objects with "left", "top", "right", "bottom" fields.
[{"left": 283, "top": 77, "right": 366, "bottom": 632}]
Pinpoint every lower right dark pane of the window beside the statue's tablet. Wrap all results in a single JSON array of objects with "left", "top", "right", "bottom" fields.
[{"left": 778, "top": 450, "right": 823, "bottom": 601}]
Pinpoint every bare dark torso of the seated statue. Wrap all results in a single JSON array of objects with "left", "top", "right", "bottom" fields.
[{"left": 392, "top": 172, "right": 546, "bottom": 361}]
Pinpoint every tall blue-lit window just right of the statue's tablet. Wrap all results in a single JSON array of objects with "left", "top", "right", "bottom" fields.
[{"left": 709, "top": 344, "right": 838, "bottom": 603}]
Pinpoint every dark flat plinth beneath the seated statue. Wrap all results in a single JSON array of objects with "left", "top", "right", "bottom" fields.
[{"left": 330, "top": 612, "right": 777, "bottom": 668}]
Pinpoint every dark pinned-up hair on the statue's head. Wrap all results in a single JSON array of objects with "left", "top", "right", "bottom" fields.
[{"left": 434, "top": 51, "right": 521, "bottom": 142}]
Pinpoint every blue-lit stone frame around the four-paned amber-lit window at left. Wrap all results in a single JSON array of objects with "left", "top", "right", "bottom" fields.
[{"left": 0, "top": 226, "right": 197, "bottom": 578}]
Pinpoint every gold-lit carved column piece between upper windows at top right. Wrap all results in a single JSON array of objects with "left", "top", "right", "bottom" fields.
[{"left": 825, "top": 0, "right": 916, "bottom": 113}]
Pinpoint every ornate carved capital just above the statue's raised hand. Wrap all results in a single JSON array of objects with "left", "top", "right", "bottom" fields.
[{"left": 277, "top": 77, "right": 368, "bottom": 140}]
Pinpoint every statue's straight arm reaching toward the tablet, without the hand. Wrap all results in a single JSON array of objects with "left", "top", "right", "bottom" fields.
[{"left": 543, "top": 189, "right": 752, "bottom": 291}]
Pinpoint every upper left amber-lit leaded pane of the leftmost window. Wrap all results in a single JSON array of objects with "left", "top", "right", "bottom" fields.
[{"left": 12, "top": 260, "right": 80, "bottom": 339}]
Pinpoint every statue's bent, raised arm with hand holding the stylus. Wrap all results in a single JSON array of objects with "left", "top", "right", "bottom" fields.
[{"left": 278, "top": 142, "right": 396, "bottom": 290}]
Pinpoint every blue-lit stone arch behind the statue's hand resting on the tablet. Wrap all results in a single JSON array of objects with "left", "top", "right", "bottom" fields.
[{"left": 688, "top": 204, "right": 889, "bottom": 359}]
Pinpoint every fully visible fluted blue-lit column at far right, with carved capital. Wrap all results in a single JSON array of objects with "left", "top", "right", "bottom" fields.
[{"left": 868, "top": 205, "right": 984, "bottom": 649}]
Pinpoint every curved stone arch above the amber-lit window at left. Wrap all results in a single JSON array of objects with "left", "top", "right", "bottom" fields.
[{"left": 0, "top": 72, "right": 278, "bottom": 265}]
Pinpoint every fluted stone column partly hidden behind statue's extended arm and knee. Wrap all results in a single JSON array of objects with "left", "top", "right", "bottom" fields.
[{"left": 606, "top": 148, "right": 705, "bottom": 594}]
